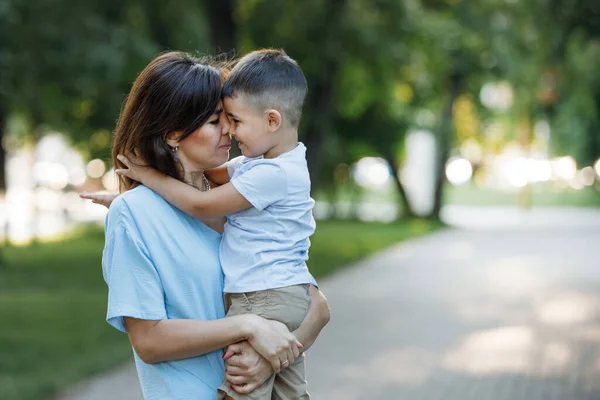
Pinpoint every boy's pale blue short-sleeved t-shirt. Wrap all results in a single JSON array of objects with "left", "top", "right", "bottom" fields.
[{"left": 221, "top": 143, "right": 315, "bottom": 293}]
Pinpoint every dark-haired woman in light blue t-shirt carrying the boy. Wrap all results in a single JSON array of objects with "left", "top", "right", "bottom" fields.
[{"left": 91, "top": 52, "right": 329, "bottom": 400}]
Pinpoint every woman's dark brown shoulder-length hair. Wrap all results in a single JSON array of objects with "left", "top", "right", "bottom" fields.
[{"left": 112, "top": 52, "right": 224, "bottom": 192}]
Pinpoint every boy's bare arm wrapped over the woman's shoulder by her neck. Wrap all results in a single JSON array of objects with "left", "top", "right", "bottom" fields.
[{"left": 115, "top": 155, "right": 252, "bottom": 219}]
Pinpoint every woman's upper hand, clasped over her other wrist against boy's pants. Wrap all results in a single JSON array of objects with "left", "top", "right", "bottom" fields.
[{"left": 248, "top": 315, "right": 304, "bottom": 373}]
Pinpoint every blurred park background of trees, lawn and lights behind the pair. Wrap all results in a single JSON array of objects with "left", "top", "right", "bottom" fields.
[{"left": 0, "top": 0, "right": 600, "bottom": 399}]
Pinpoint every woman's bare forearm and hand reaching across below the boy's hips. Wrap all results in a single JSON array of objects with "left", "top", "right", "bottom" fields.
[{"left": 124, "top": 314, "right": 302, "bottom": 371}]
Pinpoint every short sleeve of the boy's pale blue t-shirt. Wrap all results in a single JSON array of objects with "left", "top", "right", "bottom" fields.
[{"left": 231, "top": 163, "right": 287, "bottom": 211}]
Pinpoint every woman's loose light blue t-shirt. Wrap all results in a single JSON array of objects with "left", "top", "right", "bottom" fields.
[{"left": 102, "top": 186, "right": 225, "bottom": 400}]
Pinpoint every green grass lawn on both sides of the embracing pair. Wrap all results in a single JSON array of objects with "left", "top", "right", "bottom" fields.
[{"left": 0, "top": 221, "right": 440, "bottom": 400}]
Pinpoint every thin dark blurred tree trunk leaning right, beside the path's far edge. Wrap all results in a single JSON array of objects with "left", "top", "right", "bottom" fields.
[{"left": 429, "top": 71, "right": 463, "bottom": 220}]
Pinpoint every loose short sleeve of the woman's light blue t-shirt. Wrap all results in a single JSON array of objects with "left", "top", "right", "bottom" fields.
[{"left": 102, "top": 225, "right": 167, "bottom": 332}]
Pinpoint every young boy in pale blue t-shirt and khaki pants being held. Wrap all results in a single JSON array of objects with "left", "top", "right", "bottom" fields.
[{"left": 105, "top": 49, "right": 315, "bottom": 399}]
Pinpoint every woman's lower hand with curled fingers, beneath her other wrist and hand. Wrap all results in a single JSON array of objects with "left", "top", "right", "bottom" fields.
[{"left": 223, "top": 341, "right": 273, "bottom": 394}]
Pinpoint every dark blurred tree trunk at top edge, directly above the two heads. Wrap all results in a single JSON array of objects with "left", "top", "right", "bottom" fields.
[{"left": 204, "top": 0, "right": 237, "bottom": 53}]
